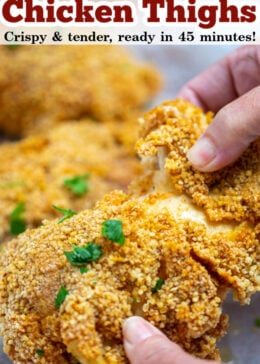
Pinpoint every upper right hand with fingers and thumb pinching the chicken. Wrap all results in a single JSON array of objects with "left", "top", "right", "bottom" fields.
[{"left": 179, "top": 46, "right": 260, "bottom": 172}]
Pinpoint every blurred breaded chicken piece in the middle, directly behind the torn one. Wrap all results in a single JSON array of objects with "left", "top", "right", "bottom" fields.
[{"left": 0, "top": 120, "right": 141, "bottom": 242}]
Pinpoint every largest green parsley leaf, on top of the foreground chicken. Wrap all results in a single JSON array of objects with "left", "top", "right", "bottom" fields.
[{"left": 64, "top": 241, "right": 103, "bottom": 266}]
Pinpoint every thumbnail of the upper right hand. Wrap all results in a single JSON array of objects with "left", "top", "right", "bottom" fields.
[{"left": 187, "top": 137, "right": 217, "bottom": 168}]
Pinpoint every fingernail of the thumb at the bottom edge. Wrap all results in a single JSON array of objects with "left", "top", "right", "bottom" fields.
[{"left": 123, "top": 317, "right": 156, "bottom": 346}]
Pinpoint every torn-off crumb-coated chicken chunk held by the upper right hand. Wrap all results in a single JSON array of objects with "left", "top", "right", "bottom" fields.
[{"left": 137, "top": 99, "right": 260, "bottom": 223}]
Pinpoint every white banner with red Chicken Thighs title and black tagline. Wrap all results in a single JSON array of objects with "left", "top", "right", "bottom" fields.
[{"left": 0, "top": 0, "right": 260, "bottom": 45}]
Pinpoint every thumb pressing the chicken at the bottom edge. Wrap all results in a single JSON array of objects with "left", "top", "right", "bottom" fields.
[{"left": 123, "top": 317, "right": 218, "bottom": 364}]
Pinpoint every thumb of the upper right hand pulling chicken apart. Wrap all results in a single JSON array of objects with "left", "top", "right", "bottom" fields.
[{"left": 188, "top": 86, "right": 260, "bottom": 172}]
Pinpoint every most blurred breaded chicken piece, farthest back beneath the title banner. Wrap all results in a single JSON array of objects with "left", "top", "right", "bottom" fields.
[{"left": 0, "top": 45, "right": 161, "bottom": 136}]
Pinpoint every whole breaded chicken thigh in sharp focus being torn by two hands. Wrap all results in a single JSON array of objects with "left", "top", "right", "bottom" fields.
[{"left": 0, "top": 100, "right": 260, "bottom": 364}]
